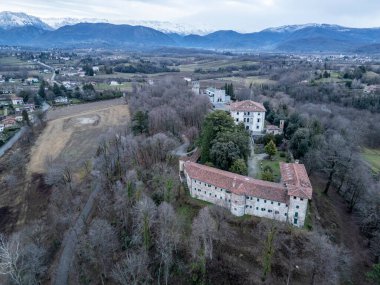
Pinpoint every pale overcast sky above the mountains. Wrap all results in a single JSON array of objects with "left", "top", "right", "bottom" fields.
[{"left": 0, "top": 0, "right": 380, "bottom": 32}]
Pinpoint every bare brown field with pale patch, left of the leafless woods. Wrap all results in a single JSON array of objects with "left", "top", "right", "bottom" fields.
[{"left": 28, "top": 100, "right": 129, "bottom": 173}]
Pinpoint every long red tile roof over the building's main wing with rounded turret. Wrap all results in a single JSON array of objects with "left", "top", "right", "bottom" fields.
[{"left": 184, "top": 161, "right": 287, "bottom": 203}]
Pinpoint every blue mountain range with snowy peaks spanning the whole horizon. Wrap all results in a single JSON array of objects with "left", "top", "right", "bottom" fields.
[{"left": 0, "top": 12, "right": 380, "bottom": 53}]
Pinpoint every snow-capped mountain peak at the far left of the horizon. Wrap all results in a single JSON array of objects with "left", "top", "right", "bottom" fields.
[{"left": 0, "top": 11, "right": 51, "bottom": 30}]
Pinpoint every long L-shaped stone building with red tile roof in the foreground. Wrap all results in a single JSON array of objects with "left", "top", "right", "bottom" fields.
[{"left": 180, "top": 158, "right": 313, "bottom": 227}]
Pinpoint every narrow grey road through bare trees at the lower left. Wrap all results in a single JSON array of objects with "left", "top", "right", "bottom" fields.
[{"left": 53, "top": 185, "right": 102, "bottom": 285}]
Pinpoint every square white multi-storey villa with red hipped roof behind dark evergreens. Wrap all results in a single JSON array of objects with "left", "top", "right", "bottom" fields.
[{"left": 230, "top": 100, "right": 266, "bottom": 133}]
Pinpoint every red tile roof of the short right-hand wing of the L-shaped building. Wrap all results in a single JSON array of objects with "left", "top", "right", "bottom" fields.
[{"left": 280, "top": 162, "right": 313, "bottom": 199}]
